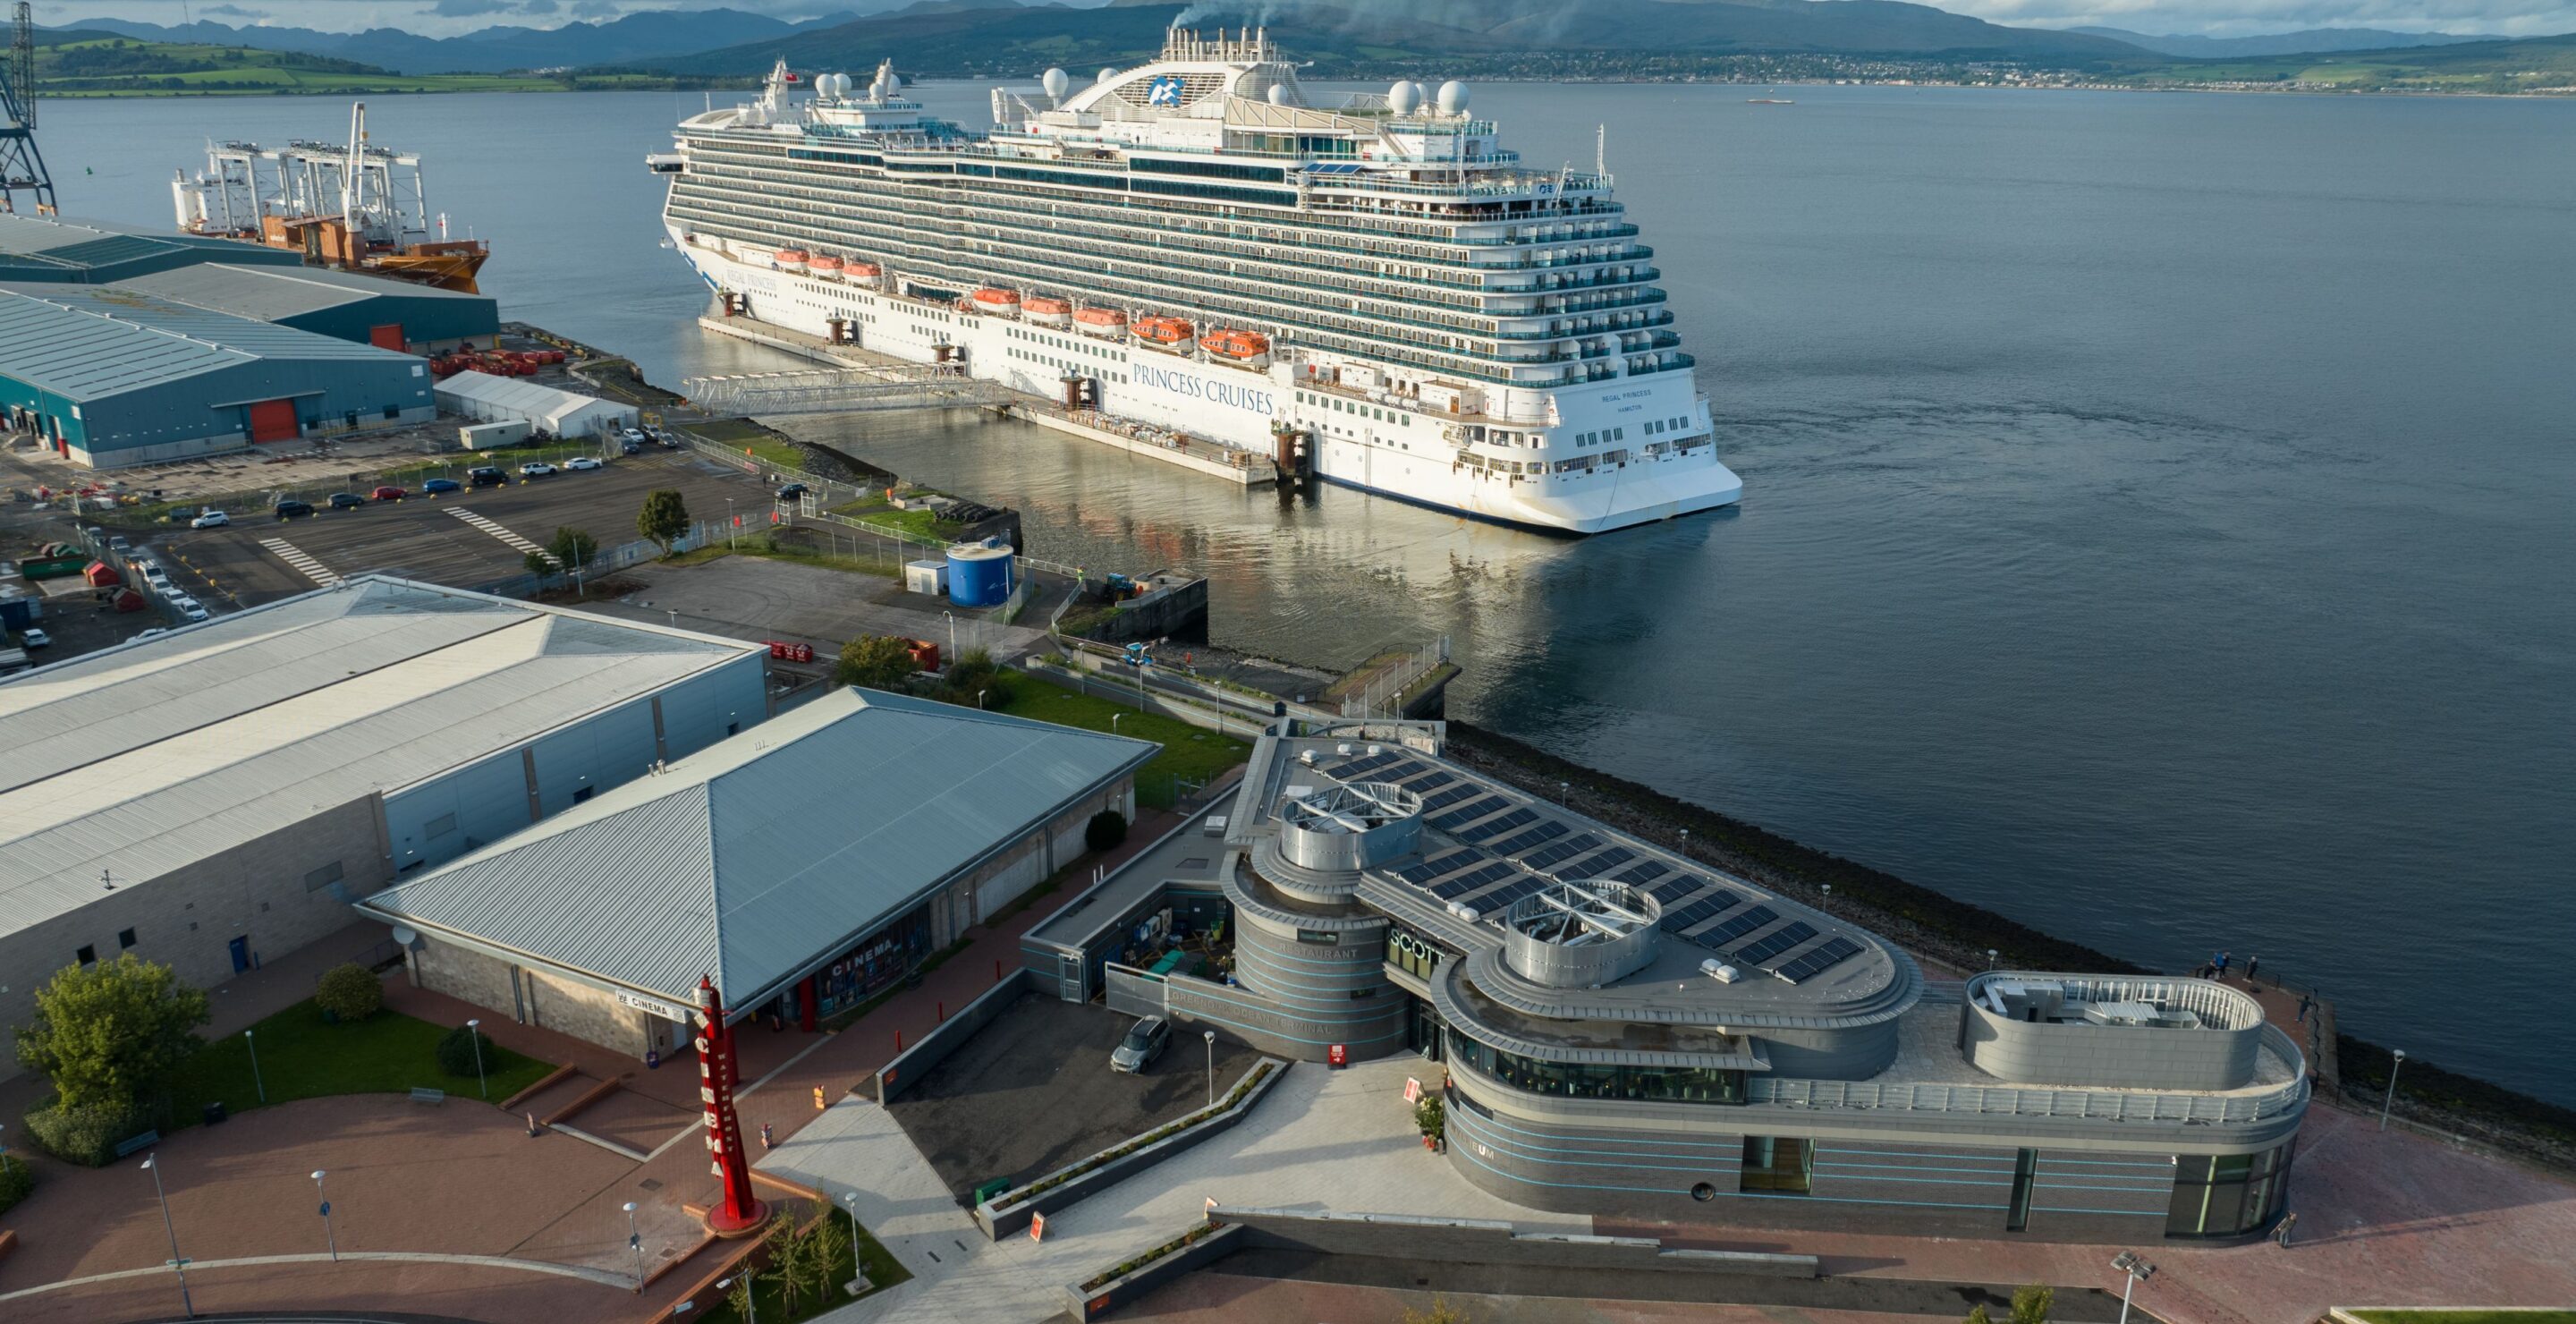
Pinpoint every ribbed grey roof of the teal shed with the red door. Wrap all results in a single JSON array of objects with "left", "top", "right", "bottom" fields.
[{"left": 0, "top": 286, "right": 407, "bottom": 399}]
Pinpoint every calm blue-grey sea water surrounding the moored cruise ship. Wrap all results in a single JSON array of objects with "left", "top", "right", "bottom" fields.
[{"left": 41, "top": 85, "right": 2576, "bottom": 1102}]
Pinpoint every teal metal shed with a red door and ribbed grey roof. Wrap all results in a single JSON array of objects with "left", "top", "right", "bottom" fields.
[{"left": 0, "top": 284, "right": 438, "bottom": 469}]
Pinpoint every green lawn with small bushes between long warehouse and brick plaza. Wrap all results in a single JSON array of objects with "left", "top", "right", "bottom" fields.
[{"left": 170, "top": 1002, "right": 554, "bottom": 1131}]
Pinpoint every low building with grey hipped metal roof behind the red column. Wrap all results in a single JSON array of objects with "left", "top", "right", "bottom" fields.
[{"left": 358, "top": 691, "right": 1157, "bottom": 1058}]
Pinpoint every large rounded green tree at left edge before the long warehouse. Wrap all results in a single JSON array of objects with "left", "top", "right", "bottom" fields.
[{"left": 18, "top": 953, "right": 206, "bottom": 1110}]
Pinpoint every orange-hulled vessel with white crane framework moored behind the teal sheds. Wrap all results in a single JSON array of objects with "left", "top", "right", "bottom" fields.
[{"left": 170, "top": 100, "right": 492, "bottom": 293}]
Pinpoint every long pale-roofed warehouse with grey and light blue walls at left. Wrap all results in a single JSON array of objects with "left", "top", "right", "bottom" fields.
[{"left": 0, "top": 577, "right": 767, "bottom": 1074}]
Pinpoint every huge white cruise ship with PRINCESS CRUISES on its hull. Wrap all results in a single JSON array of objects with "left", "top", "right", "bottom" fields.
[{"left": 647, "top": 29, "right": 1744, "bottom": 533}]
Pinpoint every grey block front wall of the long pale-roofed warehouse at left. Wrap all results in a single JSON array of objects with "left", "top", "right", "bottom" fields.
[{"left": 0, "top": 796, "right": 392, "bottom": 1079}]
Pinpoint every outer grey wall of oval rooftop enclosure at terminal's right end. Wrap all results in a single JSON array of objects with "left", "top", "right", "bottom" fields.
[{"left": 1961, "top": 1002, "right": 2262, "bottom": 1090}]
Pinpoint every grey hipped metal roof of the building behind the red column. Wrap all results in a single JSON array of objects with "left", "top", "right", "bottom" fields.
[{"left": 358, "top": 691, "right": 1157, "bottom": 1007}]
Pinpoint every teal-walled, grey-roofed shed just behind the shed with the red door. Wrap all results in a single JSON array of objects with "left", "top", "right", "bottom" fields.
[{"left": 114, "top": 263, "right": 500, "bottom": 352}]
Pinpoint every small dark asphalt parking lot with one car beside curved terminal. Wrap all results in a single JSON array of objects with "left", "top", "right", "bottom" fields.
[{"left": 886, "top": 994, "right": 1259, "bottom": 1206}]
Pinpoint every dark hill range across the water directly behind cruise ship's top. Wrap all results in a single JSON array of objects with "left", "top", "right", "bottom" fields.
[{"left": 639, "top": 0, "right": 2157, "bottom": 77}]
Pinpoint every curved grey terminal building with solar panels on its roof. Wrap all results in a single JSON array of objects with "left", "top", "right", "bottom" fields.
[{"left": 1106, "top": 724, "right": 2308, "bottom": 1244}]
